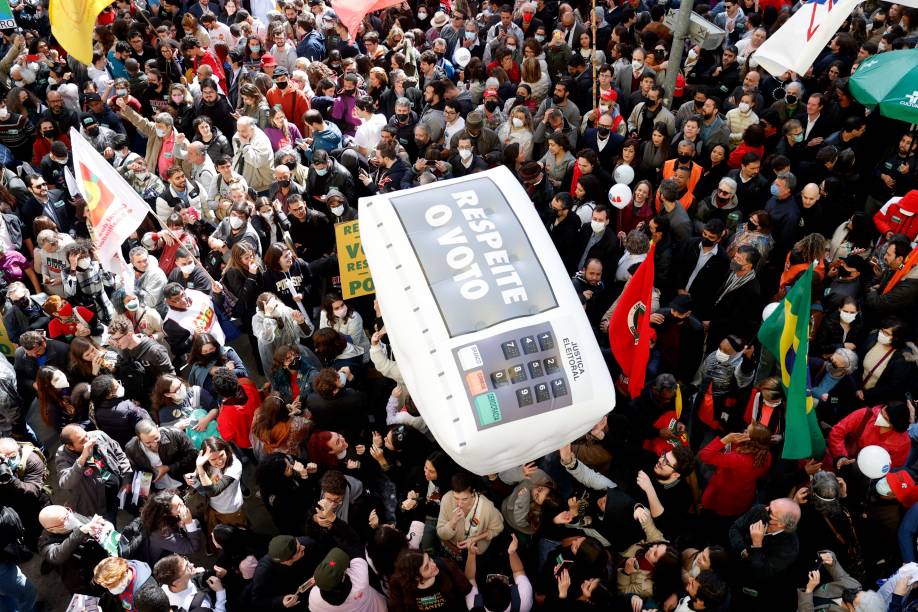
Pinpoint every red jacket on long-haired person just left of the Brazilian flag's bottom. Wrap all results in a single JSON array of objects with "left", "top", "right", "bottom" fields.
[{"left": 698, "top": 438, "right": 771, "bottom": 516}]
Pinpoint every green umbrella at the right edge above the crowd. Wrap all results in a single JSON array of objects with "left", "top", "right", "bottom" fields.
[{"left": 848, "top": 49, "right": 918, "bottom": 123}]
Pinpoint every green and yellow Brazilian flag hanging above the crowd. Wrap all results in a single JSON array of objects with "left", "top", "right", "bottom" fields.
[{"left": 759, "top": 264, "right": 826, "bottom": 459}]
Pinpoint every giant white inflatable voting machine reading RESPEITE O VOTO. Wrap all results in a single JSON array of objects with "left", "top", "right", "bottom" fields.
[{"left": 360, "top": 167, "right": 615, "bottom": 474}]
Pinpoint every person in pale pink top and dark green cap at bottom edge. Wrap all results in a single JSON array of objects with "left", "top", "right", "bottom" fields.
[{"left": 309, "top": 548, "right": 387, "bottom": 612}]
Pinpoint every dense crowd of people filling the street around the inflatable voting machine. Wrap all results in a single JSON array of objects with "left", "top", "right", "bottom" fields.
[{"left": 0, "top": 0, "right": 918, "bottom": 612}]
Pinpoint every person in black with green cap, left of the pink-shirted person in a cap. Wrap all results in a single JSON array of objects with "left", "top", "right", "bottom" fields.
[{"left": 252, "top": 535, "right": 327, "bottom": 612}]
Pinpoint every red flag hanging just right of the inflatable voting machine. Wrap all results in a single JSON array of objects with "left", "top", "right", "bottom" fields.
[{"left": 609, "top": 243, "right": 654, "bottom": 398}]
